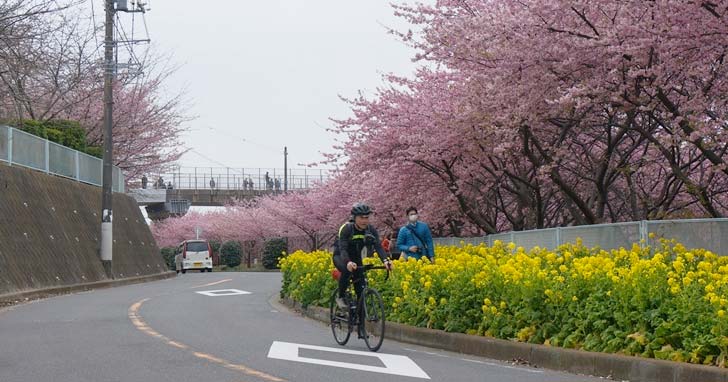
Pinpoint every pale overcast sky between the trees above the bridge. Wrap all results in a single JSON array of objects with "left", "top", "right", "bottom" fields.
[{"left": 138, "top": 0, "right": 415, "bottom": 168}]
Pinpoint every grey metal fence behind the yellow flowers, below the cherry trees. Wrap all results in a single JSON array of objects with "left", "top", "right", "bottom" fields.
[{"left": 433, "top": 218, "right": 728, "bottom": 256}]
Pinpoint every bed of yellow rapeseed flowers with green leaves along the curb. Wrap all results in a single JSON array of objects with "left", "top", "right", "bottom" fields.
[{"left": 280, "top": 241, "right": 728, "bottom": 367}]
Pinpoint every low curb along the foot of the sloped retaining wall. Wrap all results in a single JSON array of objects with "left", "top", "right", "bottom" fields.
[{"left": 0, "top": 271, "right": 176, "bottom": 304}]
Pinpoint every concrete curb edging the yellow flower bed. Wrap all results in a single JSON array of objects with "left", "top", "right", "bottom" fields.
[{"left": 281, "top": 298, "right": 728, "bottom": 382}]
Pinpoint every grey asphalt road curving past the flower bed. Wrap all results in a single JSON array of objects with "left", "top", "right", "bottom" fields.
[{"left": 0, "top": 273, "right": 602, "bottom": 382}]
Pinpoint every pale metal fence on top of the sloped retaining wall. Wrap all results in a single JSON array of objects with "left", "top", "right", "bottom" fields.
[{"left": 0, "top": 126, "right": 125, "bottom": 192}]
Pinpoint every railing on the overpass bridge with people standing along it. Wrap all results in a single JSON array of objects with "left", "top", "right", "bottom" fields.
[{"left": 134, "top": 167, "right": 332, "bottom": 191}]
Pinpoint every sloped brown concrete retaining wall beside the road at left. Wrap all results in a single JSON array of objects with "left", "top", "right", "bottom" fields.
[{"left": 0, "top": 163, "right": 167, "bottom": 295}]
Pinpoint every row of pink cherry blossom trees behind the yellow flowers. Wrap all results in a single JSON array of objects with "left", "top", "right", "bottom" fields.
[{"left": 155, "top": 0, "right": 728, "bottom": 248}]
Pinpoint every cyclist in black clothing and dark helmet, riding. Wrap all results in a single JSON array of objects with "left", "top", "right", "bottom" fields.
[{"left": 333, "top": 203, "right": 392, "bottom": 309}]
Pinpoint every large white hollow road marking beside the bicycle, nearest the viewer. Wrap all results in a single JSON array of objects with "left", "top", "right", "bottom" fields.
[{"left": 268, "top": 341, "right": 430, "bottom": 379}]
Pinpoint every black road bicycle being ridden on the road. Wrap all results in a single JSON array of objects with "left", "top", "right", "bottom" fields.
[{"left": 329, "top": 264, "right": 389, "bottom": 352}]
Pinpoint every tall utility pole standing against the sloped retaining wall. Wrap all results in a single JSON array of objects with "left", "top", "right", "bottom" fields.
[{"left": 101, "top": 0, "right": 115, "bottom": 278}]
